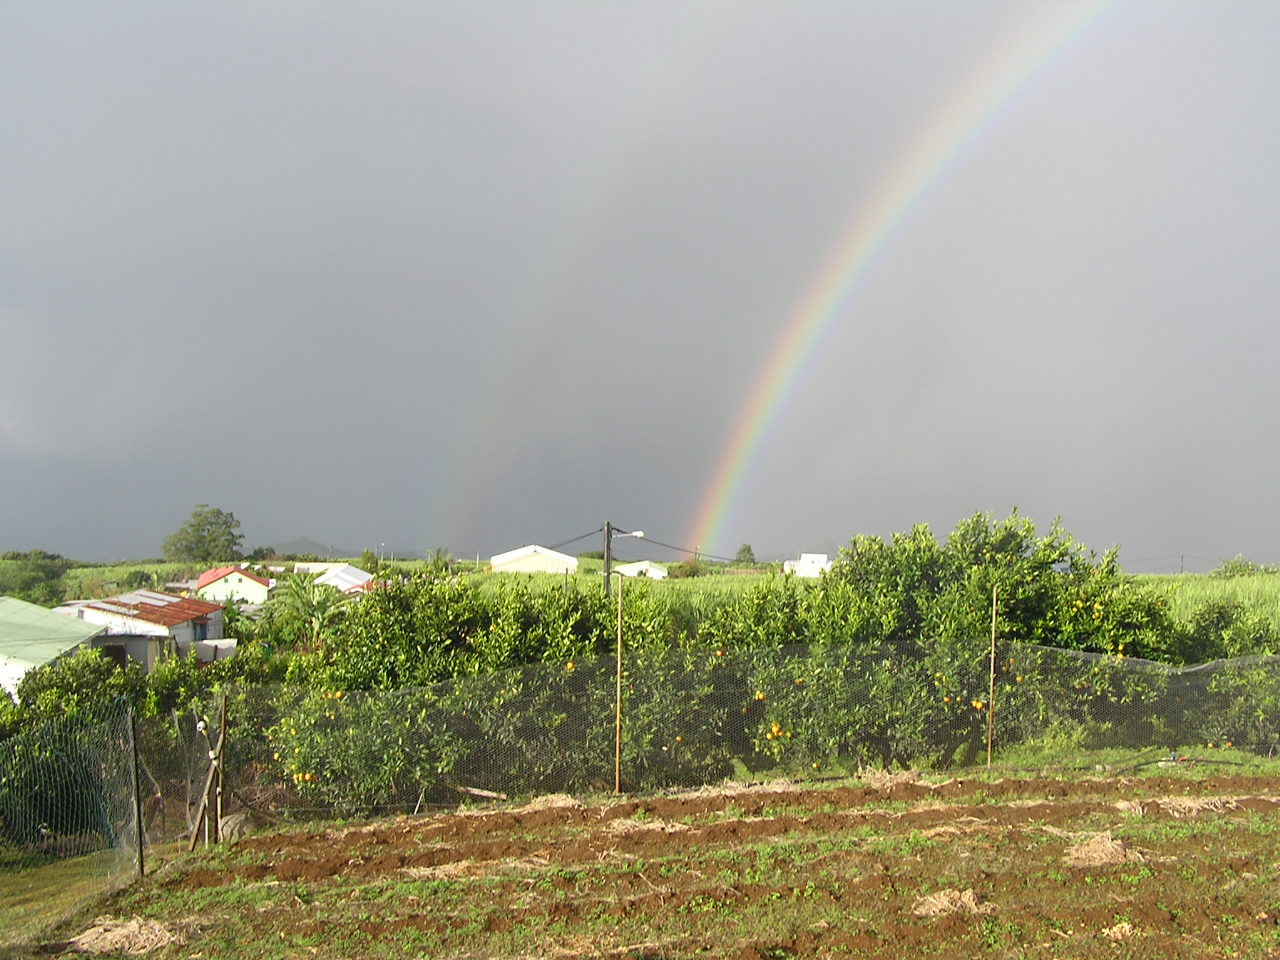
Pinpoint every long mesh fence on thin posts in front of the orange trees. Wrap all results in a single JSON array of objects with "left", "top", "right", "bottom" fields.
[{"left": 0, "top": 643, "right": 1280, "bottom": 947}]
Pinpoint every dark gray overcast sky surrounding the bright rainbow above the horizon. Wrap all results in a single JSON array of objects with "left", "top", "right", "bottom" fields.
[{"left": 0, "top": 0, "right": 1280, "bottom": 571}]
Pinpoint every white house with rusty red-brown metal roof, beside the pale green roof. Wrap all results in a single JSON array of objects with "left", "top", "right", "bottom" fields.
[{"left": 58, "top": 590, "right": 236, "bottom": 669}]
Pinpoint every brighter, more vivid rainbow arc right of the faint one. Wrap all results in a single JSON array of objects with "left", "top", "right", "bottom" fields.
[{"left": 685, "top": 0, "right": 1112, "bottom": 552}]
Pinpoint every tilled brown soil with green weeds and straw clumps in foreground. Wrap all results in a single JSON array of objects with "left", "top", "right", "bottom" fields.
[{"left": 74, "top": 772, "right": 1280, "bottom": 960}]
